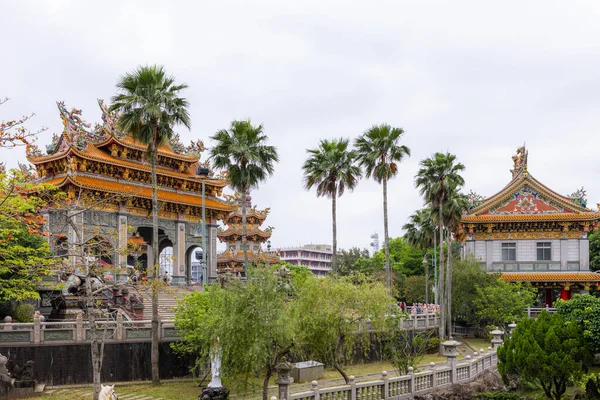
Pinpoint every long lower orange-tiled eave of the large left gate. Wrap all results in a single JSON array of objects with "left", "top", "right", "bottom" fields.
[{"left": 44, "top": 175, "right": 234, "bottom": 212}]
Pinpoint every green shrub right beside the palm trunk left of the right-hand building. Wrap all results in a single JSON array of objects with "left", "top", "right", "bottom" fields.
[{"left": 452, "top": 254, "right": 497, "bottom": 325}]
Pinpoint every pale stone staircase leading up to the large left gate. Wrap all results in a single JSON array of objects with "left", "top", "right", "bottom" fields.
[{"left": 128, "top": 285, "right": 202, "bottom": 321}]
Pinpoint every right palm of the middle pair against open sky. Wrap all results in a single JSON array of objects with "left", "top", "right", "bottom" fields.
[{"left": 354, "top": 124, "right": 410, "bottom": 290}]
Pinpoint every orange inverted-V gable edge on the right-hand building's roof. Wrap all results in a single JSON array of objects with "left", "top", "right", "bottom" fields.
[{"left": 469, "top": 172, "right": 591, "bottom": 216}]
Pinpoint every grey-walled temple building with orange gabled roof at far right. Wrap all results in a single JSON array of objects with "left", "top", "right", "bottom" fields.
[{"left": 457, "top": 146, "right": 600, "bottom": 305}]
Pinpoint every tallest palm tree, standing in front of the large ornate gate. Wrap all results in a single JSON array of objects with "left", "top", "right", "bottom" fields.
[{"left": 110, "top": 65, "right": 191, "bottom": 383}]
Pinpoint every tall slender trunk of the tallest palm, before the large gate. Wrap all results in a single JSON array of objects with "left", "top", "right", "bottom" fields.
[{"left": 150, "top": 133, "right": 160, "bottom": 384}]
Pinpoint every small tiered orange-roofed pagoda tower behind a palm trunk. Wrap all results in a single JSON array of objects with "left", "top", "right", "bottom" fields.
[{"left": 217, "top": 193, "right": 279, "bottom": 274}]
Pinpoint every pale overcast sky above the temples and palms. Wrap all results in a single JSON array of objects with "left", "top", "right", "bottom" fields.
[{"left": 0, "top": 0, "right": 600, "bottom": 252}]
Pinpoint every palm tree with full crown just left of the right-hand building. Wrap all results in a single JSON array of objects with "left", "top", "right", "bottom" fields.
[{"left": 415, "top": 153, "right": 465, "bottom": 339}]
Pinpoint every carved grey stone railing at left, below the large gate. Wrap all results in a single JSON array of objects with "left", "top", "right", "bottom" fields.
[{"left": 0, "top": 314, "right": 179, "bottom": 347}]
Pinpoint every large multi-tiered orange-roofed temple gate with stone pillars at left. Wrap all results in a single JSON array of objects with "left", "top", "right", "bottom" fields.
[{"left": 27, "top": 100, "right": 236, "bottom": 284}]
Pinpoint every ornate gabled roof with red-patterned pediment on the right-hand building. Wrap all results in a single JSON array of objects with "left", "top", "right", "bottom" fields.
[{"left": 461, "top": 146, "right": 600, "bottom": 224}]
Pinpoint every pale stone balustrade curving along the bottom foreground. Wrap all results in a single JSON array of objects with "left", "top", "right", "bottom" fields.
[{"left": 271, "top": 347, "right": 498, "bottom": 400}]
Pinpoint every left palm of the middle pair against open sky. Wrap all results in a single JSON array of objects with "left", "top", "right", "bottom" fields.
[{"left": 302, "top": 139, "right": 361, "bottom": 273}]
